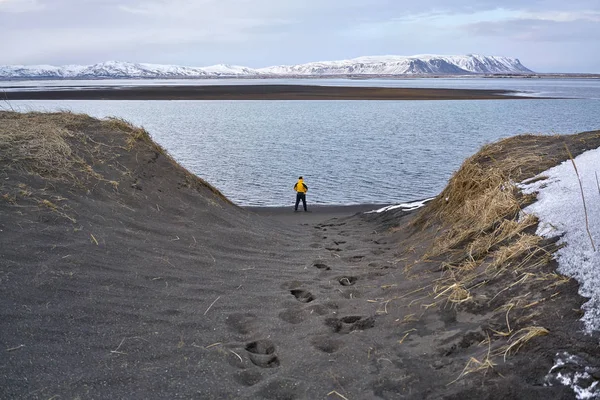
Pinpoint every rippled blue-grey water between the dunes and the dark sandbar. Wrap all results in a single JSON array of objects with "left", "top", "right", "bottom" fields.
[{"left": 2, "top": 80, "right": 600, "bottom": 206}]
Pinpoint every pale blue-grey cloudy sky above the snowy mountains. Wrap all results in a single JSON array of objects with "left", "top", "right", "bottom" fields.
[{"left": 0, "top": 0, "right": 600, "bottom": 73}]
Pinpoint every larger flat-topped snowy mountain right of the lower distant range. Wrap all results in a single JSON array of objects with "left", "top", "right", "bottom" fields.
[{"left": 258, "top": 54, "right": 532, "bottom": 75}]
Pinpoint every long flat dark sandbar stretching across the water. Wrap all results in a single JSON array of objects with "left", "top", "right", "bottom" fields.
[{"left": 2, "top": 84, "right": 540, "bottom": 100}]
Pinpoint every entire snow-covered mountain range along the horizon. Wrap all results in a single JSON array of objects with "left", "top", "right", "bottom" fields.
[{"left": 0, "top": 54, "right": 532, "bottom": 79}]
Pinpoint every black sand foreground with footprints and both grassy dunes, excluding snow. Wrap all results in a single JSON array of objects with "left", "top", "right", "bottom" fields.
[{"left": 0, "top": 112, "right": 600, "bottom": 400}]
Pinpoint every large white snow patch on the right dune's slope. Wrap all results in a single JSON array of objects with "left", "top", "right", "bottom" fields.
[{"left": 520, "top": 148, "right": 600, "bottom": 332}]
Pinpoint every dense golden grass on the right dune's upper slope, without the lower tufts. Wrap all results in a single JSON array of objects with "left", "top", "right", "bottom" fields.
[{"left": 414, "top": 135, "right": 564, "bottom": 303}]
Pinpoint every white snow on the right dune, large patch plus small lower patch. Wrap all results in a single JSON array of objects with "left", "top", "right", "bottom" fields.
[{"left": 520, "top": 148, "right": 600, "bottom": 400}]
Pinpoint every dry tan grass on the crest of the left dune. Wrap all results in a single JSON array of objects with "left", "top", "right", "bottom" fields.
[{"left": 0, "top": 111, "right": 231, "bottom": 208}]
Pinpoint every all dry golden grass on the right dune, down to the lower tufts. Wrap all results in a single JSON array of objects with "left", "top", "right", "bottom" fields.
[{"left": 413, "top": 135, "right": 580, "bottom": 378}]
